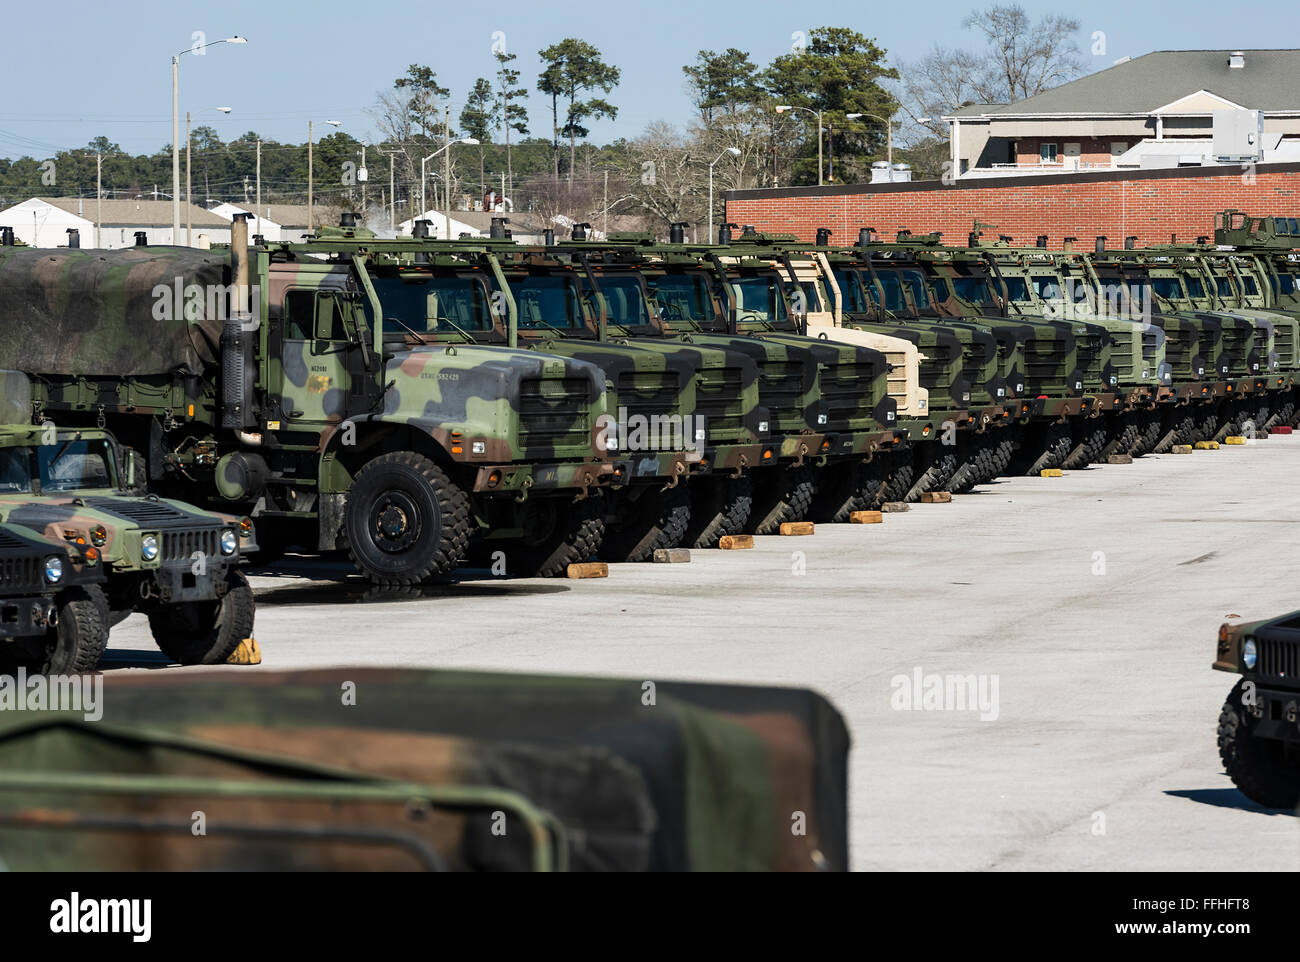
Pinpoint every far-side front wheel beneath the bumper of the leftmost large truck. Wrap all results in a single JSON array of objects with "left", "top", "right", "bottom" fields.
[{"left": 491, "top": 493, "right": 605, "bottom": 579}]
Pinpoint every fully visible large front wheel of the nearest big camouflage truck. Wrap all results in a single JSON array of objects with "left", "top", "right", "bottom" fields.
[{"left": 343, "top": 451, "right": 471, "bottom": 585}]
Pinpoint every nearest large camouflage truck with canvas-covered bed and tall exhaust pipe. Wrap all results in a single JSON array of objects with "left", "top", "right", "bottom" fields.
[{"left": 0, "top": 217, "right": 611, "bottom": 585}]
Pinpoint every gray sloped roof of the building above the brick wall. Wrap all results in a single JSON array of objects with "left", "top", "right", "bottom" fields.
[{"left": 949, "top": 49, "right": 1300, "bottom": 117}]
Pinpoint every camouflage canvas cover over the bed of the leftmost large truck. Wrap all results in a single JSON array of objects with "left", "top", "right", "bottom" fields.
[{"left": 0, "top": 247, "right": 230, "bottom": 376}]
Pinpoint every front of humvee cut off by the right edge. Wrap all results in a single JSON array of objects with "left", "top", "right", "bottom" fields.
[{"left": 1212, "top": 611, "right": 1300, "bottom": 811}]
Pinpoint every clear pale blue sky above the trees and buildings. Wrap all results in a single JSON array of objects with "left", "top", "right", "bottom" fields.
[{"left": 0, "top": 0, "right": 1300, "bottom": 157}]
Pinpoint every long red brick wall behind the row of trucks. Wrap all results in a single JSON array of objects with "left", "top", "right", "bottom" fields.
[{"left": 725, "top": 164, "right": 1300, "bottom": 247}]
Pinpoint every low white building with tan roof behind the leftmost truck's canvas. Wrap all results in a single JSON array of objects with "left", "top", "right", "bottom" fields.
[{"left": 0, "top": 198, "right": 230, "bottom": 250}]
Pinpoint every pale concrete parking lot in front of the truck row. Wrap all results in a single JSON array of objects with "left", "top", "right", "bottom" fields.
[{"left": 109, "top": 437, "right": 1300, "bottom": 870}]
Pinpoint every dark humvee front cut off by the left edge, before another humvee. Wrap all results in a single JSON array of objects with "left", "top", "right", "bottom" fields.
[{"left": 0, "top": 522, "right": 108, "bottom": 675}]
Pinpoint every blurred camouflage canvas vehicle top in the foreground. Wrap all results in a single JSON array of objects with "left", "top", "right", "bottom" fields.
[{"left": 0, "top": 668, "right": 849, "bottom": 870}]
